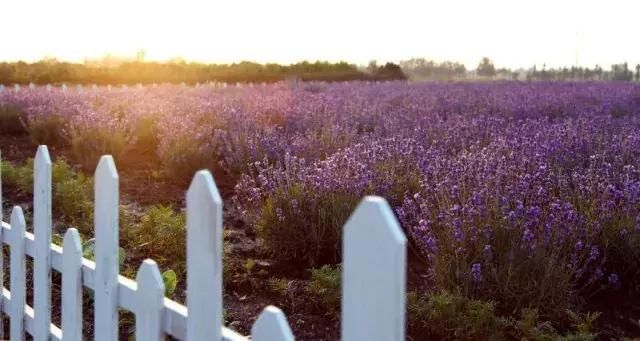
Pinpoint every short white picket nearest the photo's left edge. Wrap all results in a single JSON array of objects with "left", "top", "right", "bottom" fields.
[{"left": 9, "top": 206, "right": 26, "bottom": 341}]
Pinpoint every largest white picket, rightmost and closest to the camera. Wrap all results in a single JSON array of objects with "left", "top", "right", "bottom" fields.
[{"left": 342, "top": 196, "right": 407, "bottom": 341}]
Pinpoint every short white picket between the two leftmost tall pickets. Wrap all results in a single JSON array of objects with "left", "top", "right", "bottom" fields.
[{"left": 62, "top": 228, "right": 82, "bottom": 341}]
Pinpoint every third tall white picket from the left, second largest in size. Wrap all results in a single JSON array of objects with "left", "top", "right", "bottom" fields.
[{"left": 187, "top": 170, "right": 222, "bottom": 340}]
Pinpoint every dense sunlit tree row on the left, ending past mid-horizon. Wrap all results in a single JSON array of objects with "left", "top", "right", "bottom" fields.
[{"left": 0, "top": 59, "right": 406, "bottom": 85}]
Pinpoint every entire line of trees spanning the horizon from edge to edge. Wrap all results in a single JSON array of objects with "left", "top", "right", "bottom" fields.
[{"left": 0, "top": 57, "right": 640, "bottom": 85}]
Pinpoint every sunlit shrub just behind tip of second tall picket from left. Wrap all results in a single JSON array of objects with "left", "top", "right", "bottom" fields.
[{"left": 71, "top": 128, "right": 127, "bottom": 173}]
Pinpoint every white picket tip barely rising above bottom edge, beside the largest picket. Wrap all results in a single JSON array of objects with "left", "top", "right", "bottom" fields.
[{"left": 251, "top": 306, "right": 295, "bottom": 341}]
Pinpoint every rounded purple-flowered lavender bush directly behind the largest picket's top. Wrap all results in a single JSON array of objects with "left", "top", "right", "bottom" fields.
[{"left": 235, "top": 139, "right": 419, "bottom": 265}]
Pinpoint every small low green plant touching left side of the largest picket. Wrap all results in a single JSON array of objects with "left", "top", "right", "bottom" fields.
[{"left": 307, "top": 265, "right": 342, "bottom": 314}]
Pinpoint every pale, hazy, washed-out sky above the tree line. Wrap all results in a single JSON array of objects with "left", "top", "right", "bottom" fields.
[{"left": 0, "top": 0, "right": 640, "bottom": 68}]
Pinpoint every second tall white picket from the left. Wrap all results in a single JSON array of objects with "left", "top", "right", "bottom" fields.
[{"left": 94, "top": 155, "right": 119, "bottom": 341}]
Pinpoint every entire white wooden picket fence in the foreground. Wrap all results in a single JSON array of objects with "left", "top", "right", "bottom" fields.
[{"left": 0, "top": 146, "right": 406, "bottom": 341}]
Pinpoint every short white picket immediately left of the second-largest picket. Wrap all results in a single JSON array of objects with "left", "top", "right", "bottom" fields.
[{"left": 136, "top": 259, "right": 164, "bottom": 340}]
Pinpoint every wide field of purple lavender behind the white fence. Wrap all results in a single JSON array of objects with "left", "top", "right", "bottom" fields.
[{"left": 0, "top": 81, "right": 640, "bottom": 339}]
